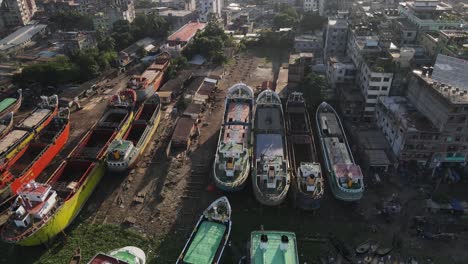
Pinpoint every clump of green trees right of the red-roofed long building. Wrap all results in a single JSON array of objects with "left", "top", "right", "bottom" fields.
[{"left": 183, "top": 22, "right": 234, "bottom": 65}]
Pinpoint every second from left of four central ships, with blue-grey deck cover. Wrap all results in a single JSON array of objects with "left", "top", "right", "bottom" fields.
[{"left": 252, "top": 90, "right": 291, "bottom": 206}]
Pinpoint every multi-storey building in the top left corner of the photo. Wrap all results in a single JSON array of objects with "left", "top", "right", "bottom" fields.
[{"left": 0, "top": 0, "right": 37, "bottom": 27}]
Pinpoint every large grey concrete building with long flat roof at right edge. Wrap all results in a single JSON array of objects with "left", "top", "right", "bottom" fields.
[{"left": 376, "top": 68, "right": 468, "bottom": 165}]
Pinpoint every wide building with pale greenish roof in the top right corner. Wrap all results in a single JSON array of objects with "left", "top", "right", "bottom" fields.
[{"left": 398, "top": 0, "right": 463, "bottom": 31}]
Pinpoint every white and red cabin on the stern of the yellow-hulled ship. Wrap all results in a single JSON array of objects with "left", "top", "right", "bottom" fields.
[{"left": 12, "top": 182, "right": 57, "bottom": 227}]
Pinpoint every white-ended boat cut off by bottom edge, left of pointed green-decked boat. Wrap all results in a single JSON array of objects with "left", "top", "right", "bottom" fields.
[{"left": 88, "top": 246, "right": 146, "bottom": 264}]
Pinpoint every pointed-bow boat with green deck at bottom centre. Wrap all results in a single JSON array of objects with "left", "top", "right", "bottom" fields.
[{"left": 176, "top": 196, "right": 232, "bottom": 264}]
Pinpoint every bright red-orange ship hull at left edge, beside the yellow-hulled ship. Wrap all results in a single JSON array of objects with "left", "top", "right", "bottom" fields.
[{"left": 0, "top": 108, "right": 70, "bottom": 224}]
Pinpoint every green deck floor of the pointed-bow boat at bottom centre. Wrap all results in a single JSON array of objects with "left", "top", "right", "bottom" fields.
[{"left": 183, "top": 221, "right": 226, "bottom": 264}]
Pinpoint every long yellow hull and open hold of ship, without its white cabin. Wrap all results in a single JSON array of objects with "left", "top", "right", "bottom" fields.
[{"left": 1, "top": 94, "right": 135, "bottom": 246}]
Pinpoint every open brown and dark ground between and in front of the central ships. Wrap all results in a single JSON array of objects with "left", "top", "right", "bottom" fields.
[{"left": 81, "top": 51, "right": 468, "bottom": 263}]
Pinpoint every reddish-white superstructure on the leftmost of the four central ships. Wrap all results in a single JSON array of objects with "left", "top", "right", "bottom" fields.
[{"left": 219, "top": 125, "right": 248, "bottom": 177}]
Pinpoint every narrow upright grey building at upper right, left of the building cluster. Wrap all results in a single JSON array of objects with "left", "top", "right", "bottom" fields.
[{"left": 324, "top": 18, "right": 348, "bottom": 58}]
